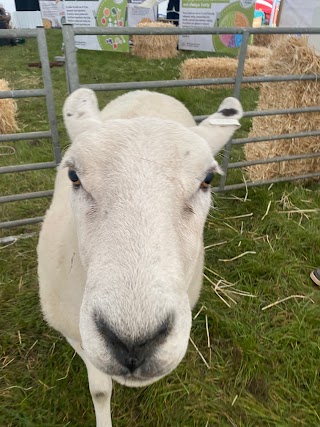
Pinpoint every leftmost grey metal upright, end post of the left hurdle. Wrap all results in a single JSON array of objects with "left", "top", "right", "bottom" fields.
[{"left": 37, "top": 27, "right": 61, "bottom": 165}]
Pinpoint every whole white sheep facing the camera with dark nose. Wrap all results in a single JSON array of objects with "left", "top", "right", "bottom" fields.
[{"left": 38, "top": 89, "right": 242, "bottom": 427}]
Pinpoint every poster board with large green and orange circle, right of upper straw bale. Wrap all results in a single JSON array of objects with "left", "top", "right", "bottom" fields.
[{"left": 179, "top": 0, "right": 255, "bottom": 53}]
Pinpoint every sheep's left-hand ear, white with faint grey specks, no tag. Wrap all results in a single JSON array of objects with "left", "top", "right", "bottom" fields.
[{"left": 63, "top": 88, "right": 101, "bottom": 140}]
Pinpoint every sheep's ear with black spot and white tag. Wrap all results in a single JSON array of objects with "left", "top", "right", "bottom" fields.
[{"left": 192, "top": 97, "right": 243, "bottom": 155}]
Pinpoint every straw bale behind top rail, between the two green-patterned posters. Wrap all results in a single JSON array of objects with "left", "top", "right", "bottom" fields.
[{"left": 132, "top": 22, "right": 178, "bottom": 59}]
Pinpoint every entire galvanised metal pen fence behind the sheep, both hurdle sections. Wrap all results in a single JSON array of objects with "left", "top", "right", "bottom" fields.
[{"left": 0, "top": 25, "right": 320, "bottom": 239}]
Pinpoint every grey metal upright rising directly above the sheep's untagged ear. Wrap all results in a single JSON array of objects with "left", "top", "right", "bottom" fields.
[{"left": 62, "top": 24, "right": 80, "bottom": 93}]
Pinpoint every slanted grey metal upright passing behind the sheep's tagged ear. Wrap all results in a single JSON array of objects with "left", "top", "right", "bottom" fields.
[{"left": 219, "top": 30, "right": 250, "bottom": 191}]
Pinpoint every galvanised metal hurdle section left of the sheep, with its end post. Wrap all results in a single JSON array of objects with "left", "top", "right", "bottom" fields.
[{"left": 0, "top": 27, "right": 61, "bottom": 234}]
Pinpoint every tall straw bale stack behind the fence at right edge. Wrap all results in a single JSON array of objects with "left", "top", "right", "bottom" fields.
[{"left": 244, "top": 36, "right": 320, "bottom": 181}]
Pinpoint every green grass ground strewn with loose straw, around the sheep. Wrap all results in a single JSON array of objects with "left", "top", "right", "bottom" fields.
[{"left": 0, "top": 30, "right": 320, "bottom": 427}]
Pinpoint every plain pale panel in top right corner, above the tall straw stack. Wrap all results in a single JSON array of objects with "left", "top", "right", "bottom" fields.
[{"left": 279, "top": 0, "right": 320, "bottom": 54}]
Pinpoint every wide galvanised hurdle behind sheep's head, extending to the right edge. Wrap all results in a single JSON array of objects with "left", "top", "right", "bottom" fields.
[{"left": 63, "top": 25, "right": 320, "bottom": 192}]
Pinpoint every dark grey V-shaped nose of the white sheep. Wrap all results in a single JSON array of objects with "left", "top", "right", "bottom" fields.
[{"left": 94, "top": 314, "right": 173, "bottom": 373}]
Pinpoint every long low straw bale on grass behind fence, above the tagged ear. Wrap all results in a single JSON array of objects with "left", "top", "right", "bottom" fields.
[{"left": 180, "top": 58, "right": 266, "bottom": 89}]
